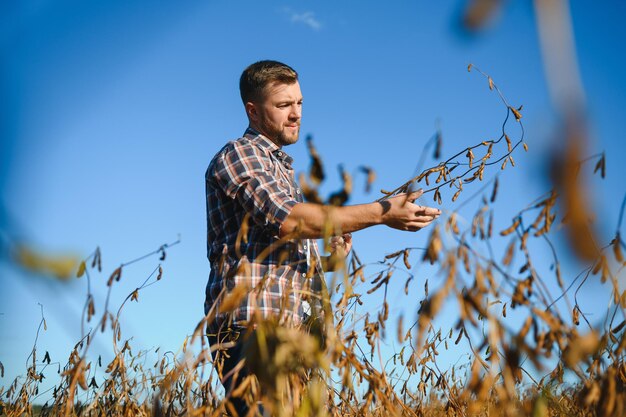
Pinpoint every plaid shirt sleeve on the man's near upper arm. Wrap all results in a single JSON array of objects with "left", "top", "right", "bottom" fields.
[{"left": 213, "top": 142, "right": 297, "bottom": 236}]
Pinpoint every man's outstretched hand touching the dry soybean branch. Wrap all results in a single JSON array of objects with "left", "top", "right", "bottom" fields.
[{"left": 380, "top": 190, "right": 441, "bottom": 232}]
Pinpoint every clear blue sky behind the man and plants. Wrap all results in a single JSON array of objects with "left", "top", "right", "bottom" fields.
[{"left": 0, "top": 0, "right": 626, "bottom": 396}]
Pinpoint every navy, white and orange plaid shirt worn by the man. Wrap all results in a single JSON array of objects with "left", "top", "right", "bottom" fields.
[{"left": 204, "top": 128, "right": 323, "bottom": 328}]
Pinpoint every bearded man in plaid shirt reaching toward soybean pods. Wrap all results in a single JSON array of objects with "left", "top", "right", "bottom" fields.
[{"left": 205, "top": 61, "right": 440, "bottom": 415}]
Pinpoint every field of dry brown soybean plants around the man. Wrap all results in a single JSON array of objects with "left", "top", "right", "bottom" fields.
[{"left": 0, "top": 66, "right": 626, "bottom": 417}]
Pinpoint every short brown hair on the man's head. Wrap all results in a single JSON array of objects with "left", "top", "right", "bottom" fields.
[{"left": 239, "top": 60, "right": 298, "bottom": 104}]
